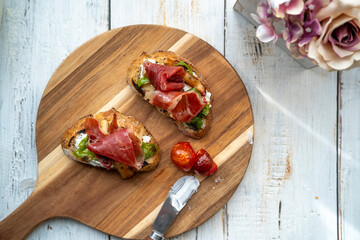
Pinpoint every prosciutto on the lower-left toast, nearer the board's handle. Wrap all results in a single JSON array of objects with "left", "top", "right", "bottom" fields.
[{"left": 84, "top": 116, "right": 145, "bottom": 169}]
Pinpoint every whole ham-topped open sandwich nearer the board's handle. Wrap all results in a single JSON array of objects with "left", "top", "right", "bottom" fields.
[{"left": 61, "top": 109, "right": 160, "bottom": 179}]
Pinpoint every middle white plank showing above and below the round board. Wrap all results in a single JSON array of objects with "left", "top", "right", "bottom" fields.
[{"left": 111, "top": 0, "right": 226, "bottom": 240}]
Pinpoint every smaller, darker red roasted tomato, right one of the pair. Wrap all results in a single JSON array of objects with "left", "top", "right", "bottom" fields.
[{"left": 194, "top": 149, "right": 217, "bottom": 176}]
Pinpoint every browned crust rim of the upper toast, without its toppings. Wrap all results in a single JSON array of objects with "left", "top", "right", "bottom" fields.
[{"left": 127, "top": 51, "right": 213, "bottom": 138}]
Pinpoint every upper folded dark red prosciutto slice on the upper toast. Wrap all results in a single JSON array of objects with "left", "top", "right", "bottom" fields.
[{"left": 143, "top": 61, "right": 186, "bottom": 91}]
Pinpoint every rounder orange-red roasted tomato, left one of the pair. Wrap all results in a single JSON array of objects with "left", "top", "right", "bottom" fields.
[{"left": 171, "top": 142, "right": 196, "bottom": 172}]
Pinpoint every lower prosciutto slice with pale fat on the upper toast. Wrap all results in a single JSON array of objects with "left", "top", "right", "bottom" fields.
[{"left": 148, "top": 90, "right": 207, "bottom": 122}]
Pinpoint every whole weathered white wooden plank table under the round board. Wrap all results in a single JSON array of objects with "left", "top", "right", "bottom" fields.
[{"left": 0, "top": 0, "right": 360, "bottom": 240}]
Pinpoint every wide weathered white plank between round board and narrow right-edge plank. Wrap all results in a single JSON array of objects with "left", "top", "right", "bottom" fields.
[{"left": 225, "top": 0, "right": 337, "bottom": 240}]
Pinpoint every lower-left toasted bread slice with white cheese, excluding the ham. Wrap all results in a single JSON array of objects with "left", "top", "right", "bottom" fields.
[{"left": 61, "top": 109, "right": 160, "bottom": 179}]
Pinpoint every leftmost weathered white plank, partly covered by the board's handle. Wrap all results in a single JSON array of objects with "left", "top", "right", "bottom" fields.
[{"left": 0, "top": 0, "right": 108, "bottom": 239}]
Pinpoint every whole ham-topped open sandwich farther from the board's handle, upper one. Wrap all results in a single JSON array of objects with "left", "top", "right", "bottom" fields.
[{"left": 127, "top": 51, "right": 212, "bottom": 138}]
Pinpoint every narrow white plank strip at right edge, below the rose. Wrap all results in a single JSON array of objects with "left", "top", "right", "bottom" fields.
[{"left": 338, "top": 69, "right": 360, "bottom": 240}]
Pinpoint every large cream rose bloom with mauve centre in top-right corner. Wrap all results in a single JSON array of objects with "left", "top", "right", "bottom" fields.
[{"left": 303, "top": 0, "right": 360, "bottom": 71}]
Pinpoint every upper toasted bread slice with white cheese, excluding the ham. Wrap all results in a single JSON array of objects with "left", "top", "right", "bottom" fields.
[{"left": 127, "top": 51, "right": 213, "bottom": 138}]
